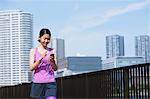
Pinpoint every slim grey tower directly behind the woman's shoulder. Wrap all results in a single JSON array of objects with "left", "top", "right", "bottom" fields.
[{"left": 49, "top": 38, "right": 66, "bottom": 69}]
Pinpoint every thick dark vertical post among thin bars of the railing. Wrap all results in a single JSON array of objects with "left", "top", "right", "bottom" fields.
[{"left": 123, "top": 69, "right": 129, "bottom": 99}]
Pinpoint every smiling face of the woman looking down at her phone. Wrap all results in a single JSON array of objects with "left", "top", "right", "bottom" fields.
[{"left": 39, "top": 34, "right": 50, "bottom": 47}]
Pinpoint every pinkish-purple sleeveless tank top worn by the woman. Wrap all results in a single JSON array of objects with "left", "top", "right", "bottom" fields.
[{"left": 33, "top": 48, "right": 55, "bottom": 83}]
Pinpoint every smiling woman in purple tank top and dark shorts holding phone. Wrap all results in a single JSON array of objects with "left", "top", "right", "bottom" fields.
[{"left": 30, "top": 28, "right": 57, "bottom": 99}]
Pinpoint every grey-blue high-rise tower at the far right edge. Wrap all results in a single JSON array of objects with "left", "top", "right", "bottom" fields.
[{"left": 135, "top": 35, "right": 150, "bottom": 62}]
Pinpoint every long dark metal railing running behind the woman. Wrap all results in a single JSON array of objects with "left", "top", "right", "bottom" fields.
[{"left": 0, "top": 63, "right": 150, "bottom": 99}]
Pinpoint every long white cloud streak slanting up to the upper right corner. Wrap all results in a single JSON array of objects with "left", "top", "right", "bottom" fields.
[{"left": 60, "top": 0, "right": 150, "bottom": 35}]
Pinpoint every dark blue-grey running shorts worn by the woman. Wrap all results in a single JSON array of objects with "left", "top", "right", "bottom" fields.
[{"left": 30, "top": 82, "right": 57, "bottom": 98}]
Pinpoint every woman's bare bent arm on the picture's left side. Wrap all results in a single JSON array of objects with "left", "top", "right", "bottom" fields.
[{"left": 29, "top": 49, "right": 43, "bottom": 71}]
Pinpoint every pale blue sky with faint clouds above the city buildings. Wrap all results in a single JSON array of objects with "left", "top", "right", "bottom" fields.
[{"left": 0, "top": 0, "right": 150, "bottom": 59}]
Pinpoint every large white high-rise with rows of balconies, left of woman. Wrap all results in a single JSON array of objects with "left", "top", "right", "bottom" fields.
[{"left": 0, "top": 10, "right": 32, "bottom": 86}]
